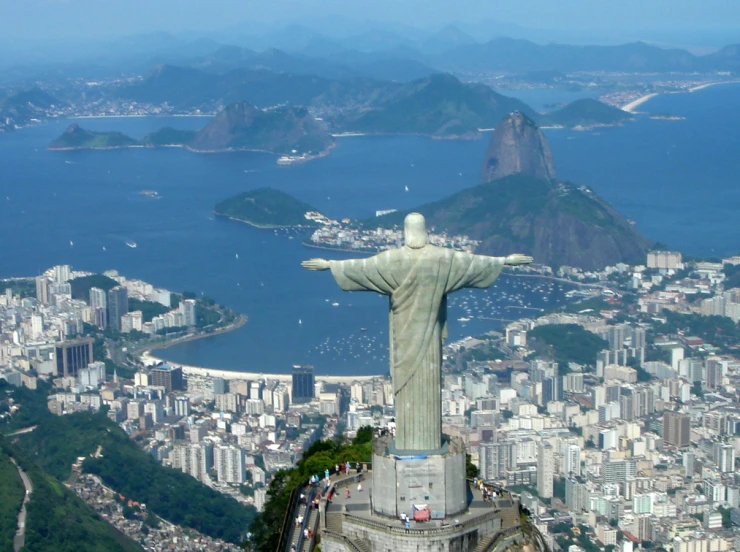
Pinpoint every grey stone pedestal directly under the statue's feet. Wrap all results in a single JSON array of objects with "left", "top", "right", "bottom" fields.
[{"left": 372, "top": 435, "right": 469, "bottom": 519}]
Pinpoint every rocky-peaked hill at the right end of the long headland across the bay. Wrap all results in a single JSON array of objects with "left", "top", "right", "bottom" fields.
[{"left": 189, "top": 102, "right": 334, "bottom": 155}]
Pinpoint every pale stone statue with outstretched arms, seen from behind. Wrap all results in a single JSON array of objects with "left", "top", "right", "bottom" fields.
[{"left": 302, "top": 213, "right": 532, "bottom": 452}]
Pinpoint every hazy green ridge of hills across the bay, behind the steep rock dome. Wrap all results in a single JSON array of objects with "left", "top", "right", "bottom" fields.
[{"left": 118, "top": 66, "right": 631, "bottom": 137}]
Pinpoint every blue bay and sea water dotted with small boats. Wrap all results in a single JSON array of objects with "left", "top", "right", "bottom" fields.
[{"left": 0, "top": 85, "right": 740, "bottom": 375}]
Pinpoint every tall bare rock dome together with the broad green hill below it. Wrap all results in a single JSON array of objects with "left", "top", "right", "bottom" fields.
[{"left": 370, "top": 112, "right": 650, "bottom": 270}]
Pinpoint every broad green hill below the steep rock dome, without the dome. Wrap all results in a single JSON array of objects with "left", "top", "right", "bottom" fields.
[{"left": 372, "top": 174, "right": 650, "bottom": 270}]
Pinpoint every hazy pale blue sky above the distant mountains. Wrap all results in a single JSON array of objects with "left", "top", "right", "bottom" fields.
[{"left": 0, "top": 0, "right": 740, "bottom": 39}]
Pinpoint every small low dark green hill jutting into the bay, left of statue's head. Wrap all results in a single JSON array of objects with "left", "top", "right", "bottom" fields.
[{"left": 215, "top": 188, "right": 316, "bottom": 228}]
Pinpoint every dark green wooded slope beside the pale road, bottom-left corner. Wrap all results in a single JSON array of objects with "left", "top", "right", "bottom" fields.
[{"left": 0, "top": 437, "right": 143, "bottom": 552}]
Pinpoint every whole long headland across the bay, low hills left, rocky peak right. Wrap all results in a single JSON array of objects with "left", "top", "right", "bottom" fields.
[{"left": 49, "top": 102, "right": 334, "bottom": 164}]
